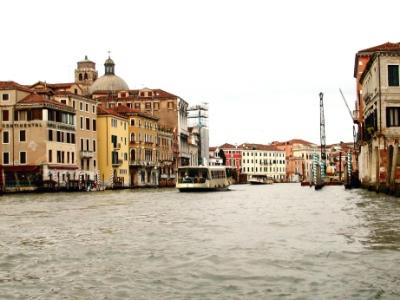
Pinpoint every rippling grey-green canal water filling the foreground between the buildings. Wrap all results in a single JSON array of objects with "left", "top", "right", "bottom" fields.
[{"left": 0, "top": 184, "right": 400, "bottom": 299}]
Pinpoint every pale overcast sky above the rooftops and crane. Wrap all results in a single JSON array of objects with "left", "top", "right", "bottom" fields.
[{"left": 0, "top": 0, "right": 400, "bottom": 145}]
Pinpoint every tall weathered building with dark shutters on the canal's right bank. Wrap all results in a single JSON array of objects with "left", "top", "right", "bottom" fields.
[{"left": 355, "top": 43, "right": 400, "bottom": 189}]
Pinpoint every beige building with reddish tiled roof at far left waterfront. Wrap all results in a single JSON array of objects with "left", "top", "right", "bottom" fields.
[{"left": 0, "top": 82, "right": 78, "bottom": 190}]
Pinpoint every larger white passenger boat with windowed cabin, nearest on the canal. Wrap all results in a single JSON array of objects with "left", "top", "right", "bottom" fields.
[{"left": 176, "top": 166, "right": 231, "bottom": 192}]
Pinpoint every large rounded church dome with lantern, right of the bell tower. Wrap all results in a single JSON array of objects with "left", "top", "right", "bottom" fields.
[{"left": 89, "top": 57, "right": 129, "bottom": 94}]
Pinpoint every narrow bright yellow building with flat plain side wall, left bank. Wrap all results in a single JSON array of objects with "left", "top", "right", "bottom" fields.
[{"left": 97, "top": 107, "right": 130, "bottom": 188}]
